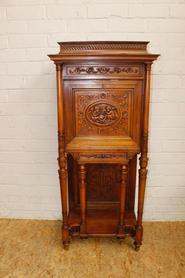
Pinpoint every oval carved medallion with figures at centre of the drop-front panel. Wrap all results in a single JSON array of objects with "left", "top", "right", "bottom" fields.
[{"left": 85, "top": 102, "right": 120, "bottom": 126}]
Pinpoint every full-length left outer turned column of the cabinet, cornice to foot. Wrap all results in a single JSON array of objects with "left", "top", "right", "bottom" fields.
[{"left": 56, "top": 64, "right": 69, "bottom": 249}]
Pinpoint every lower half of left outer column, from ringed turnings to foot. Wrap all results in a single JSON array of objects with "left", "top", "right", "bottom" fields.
[{"left": 58, "top": 131, "right": 70, "bottom": 249}]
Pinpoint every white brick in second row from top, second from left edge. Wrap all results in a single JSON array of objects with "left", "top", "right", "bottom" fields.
[{"left": 28, "top": 20, "right": 66, "bottom": 34}]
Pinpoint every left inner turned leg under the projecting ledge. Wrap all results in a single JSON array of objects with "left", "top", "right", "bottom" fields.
[{"left": 79, "top": 165, "right": 87, "bottom": 238}]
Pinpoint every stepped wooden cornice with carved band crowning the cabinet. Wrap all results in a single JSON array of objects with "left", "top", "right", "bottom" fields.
[{"left": 48, "top": 41, "right": 159, "bottom": 63}]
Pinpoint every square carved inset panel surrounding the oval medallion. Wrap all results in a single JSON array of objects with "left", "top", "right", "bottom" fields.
[{"left": 75, "top": 89, "right": 132, "bottom": 136}]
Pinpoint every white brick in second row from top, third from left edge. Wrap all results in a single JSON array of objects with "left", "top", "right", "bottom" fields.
[{"left": 67, "top": 19, "right": 107, "bottom": 33}]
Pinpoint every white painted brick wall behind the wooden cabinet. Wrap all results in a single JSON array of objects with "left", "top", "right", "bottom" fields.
[{"left": 0, "top": 0, "right": 185, "bottom": 220}]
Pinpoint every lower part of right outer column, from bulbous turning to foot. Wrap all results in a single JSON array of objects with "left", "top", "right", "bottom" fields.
[{"left": 134, "top": 153, "right": 148, "bottom": 251}]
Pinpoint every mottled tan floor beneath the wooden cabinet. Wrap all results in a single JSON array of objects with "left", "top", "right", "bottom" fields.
[{"left": 0, "top": 219, "right": 185, "bottom": 278}]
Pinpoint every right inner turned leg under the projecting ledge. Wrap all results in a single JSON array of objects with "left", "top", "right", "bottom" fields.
[{"left": 117, "top": 165, "right": 128, "bottom": 239}]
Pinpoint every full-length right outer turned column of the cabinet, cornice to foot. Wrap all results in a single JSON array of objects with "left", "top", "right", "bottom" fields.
[{"left": 134, "top": 63, "right": 151, "bottom": 250}]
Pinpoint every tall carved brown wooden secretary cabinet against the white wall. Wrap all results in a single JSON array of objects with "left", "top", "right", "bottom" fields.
[{"left": 49, "top": 41, "right": 159, "bottom": 250}]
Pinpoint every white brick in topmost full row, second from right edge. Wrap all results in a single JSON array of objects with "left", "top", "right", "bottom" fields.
[{"left": 129, "top": 4, "right": 169, "bottom": 18}]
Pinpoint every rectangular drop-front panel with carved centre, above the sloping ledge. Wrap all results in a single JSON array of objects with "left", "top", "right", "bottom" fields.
[{"left": 64, "top": 80, "right": 142, "bottom": 145}]
